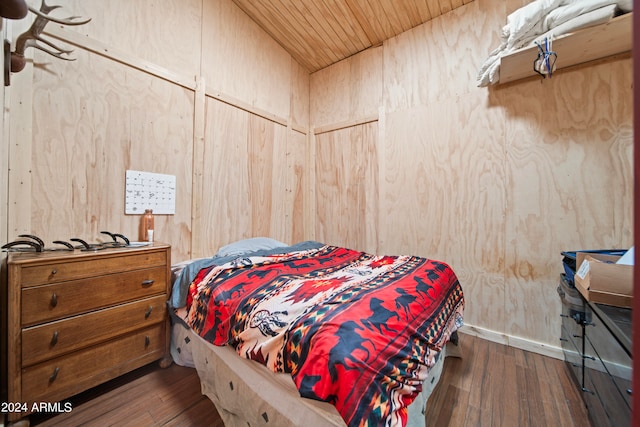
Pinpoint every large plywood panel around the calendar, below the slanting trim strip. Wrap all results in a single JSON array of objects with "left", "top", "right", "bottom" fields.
[{"left": 30, "top": 51, "right": 194, "bottom": 260}]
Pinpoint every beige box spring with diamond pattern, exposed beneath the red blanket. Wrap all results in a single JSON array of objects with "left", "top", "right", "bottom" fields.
[{"left": 171, "top": 321, "right": 461, "bottom": 427}]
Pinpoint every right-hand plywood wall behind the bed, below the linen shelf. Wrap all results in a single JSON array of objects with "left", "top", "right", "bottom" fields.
[{"left": 310, "top": 0, "right": 633, "bottom": 355}]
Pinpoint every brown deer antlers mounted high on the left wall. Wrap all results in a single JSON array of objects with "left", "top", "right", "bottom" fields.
[{"left": 4, "top": 0, "right": 91, "bottom": 86}]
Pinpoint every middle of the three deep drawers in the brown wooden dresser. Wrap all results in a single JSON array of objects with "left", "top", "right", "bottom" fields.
[{"left": 22, "top": 294, "right": 167, "bottom": 366}]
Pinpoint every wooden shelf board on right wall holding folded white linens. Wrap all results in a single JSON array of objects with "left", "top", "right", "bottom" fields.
[{"left": 498, "top": 13, "right": 633, "bottom": 84}]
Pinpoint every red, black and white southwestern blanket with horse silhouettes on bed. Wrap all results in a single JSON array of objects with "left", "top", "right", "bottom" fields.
[{"left": 180, "top": 245, "right": 464, "bottom": 426}]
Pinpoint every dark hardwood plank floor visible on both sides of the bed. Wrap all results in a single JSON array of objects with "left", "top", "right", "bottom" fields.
[{"left": 31, "top": 334, "right": 590, "bottom": 427}]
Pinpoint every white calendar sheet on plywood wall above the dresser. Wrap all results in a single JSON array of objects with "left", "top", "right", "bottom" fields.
[{"left": 124, "top": 170, "right": 176, "bottom": 215}]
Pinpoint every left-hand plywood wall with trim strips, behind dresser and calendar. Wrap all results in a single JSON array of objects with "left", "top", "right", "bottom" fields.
[{"left": 3, "top": 0, "right": 309, "bottom": 262}]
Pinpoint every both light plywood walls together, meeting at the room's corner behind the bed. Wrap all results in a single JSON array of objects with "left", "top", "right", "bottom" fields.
[{"left": 0, "top": 0, "right": 632, "bottom": 351}]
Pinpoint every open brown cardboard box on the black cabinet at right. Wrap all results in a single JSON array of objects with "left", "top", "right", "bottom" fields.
[{"left": 574, "top": 252, "right": 633, "bottom": 307}]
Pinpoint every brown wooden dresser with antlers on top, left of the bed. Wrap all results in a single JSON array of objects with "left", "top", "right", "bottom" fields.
[{"left": 3, "top": 243, "right": 171, "bottom": 421}]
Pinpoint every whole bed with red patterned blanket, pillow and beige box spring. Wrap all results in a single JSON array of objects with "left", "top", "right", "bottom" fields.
[{"left": 169, "top": 238, "right": 464, "bottom": 427}]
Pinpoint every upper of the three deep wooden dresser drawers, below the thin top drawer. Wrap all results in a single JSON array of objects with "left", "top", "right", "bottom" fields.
[{"left": 22, "top": 266, "right": 167, "bottom": 326}]
